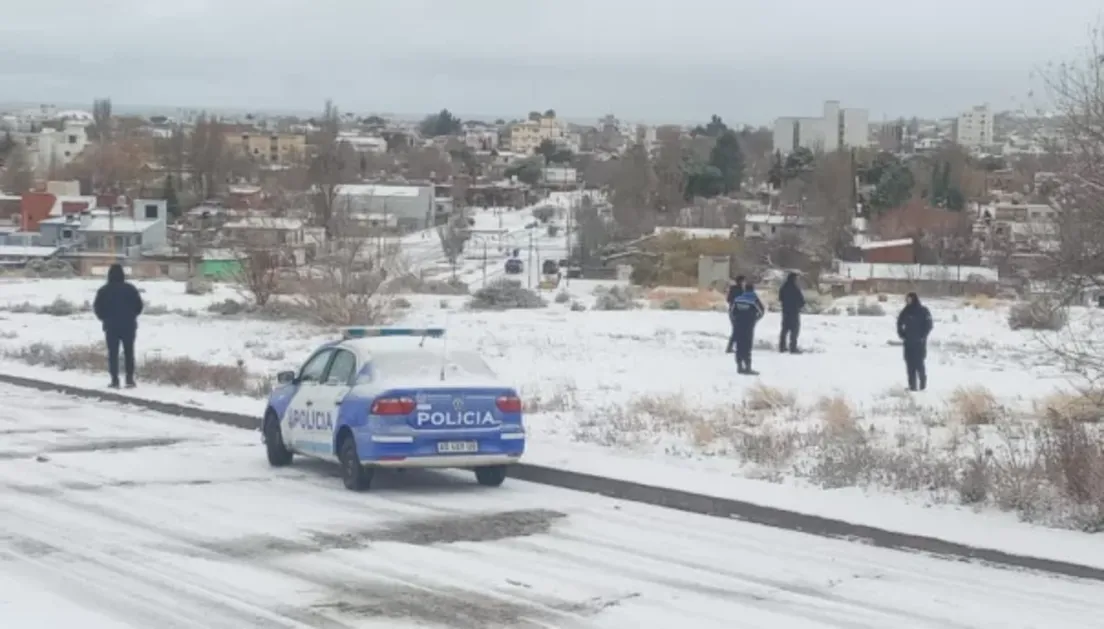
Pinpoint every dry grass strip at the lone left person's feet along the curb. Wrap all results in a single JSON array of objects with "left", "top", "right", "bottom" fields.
[{"left": 4, "top": 343, "right": 267, "bottom": 397}]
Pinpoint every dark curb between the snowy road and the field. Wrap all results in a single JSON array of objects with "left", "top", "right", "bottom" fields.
[{"left": 0, "top": 374, "right": 1104, "bottom": 582}]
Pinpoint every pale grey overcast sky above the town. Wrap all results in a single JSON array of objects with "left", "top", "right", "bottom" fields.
[{"left": 0, "top": 0, "right": 1104, "bottom": 124}]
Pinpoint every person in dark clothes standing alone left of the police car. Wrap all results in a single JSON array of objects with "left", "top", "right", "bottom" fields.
[{"left": 93, "top": 264, "right": 142, "bottom": 388}]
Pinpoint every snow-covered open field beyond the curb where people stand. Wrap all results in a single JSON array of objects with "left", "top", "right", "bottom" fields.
[{"left": 0, "top": 273, "right": 1104, "bottom": 566}]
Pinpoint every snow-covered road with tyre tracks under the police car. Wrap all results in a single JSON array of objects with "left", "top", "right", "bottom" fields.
[{"left": 0, "top": 386, "right": 1104, "bottom": 629}]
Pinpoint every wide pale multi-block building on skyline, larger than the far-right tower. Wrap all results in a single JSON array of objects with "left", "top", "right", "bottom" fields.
[{"left": 774, "top": 100, "right": 870, "bottom": 154}]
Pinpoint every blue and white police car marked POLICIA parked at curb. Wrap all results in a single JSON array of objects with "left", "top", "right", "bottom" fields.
[{"left": 262, "top": 328, "right": 526, "bottom": 491}]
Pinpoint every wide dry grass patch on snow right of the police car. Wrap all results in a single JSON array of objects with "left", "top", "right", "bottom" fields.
[{"left": 574, "top": 386, "right": 1104, "bottom": 531}]
